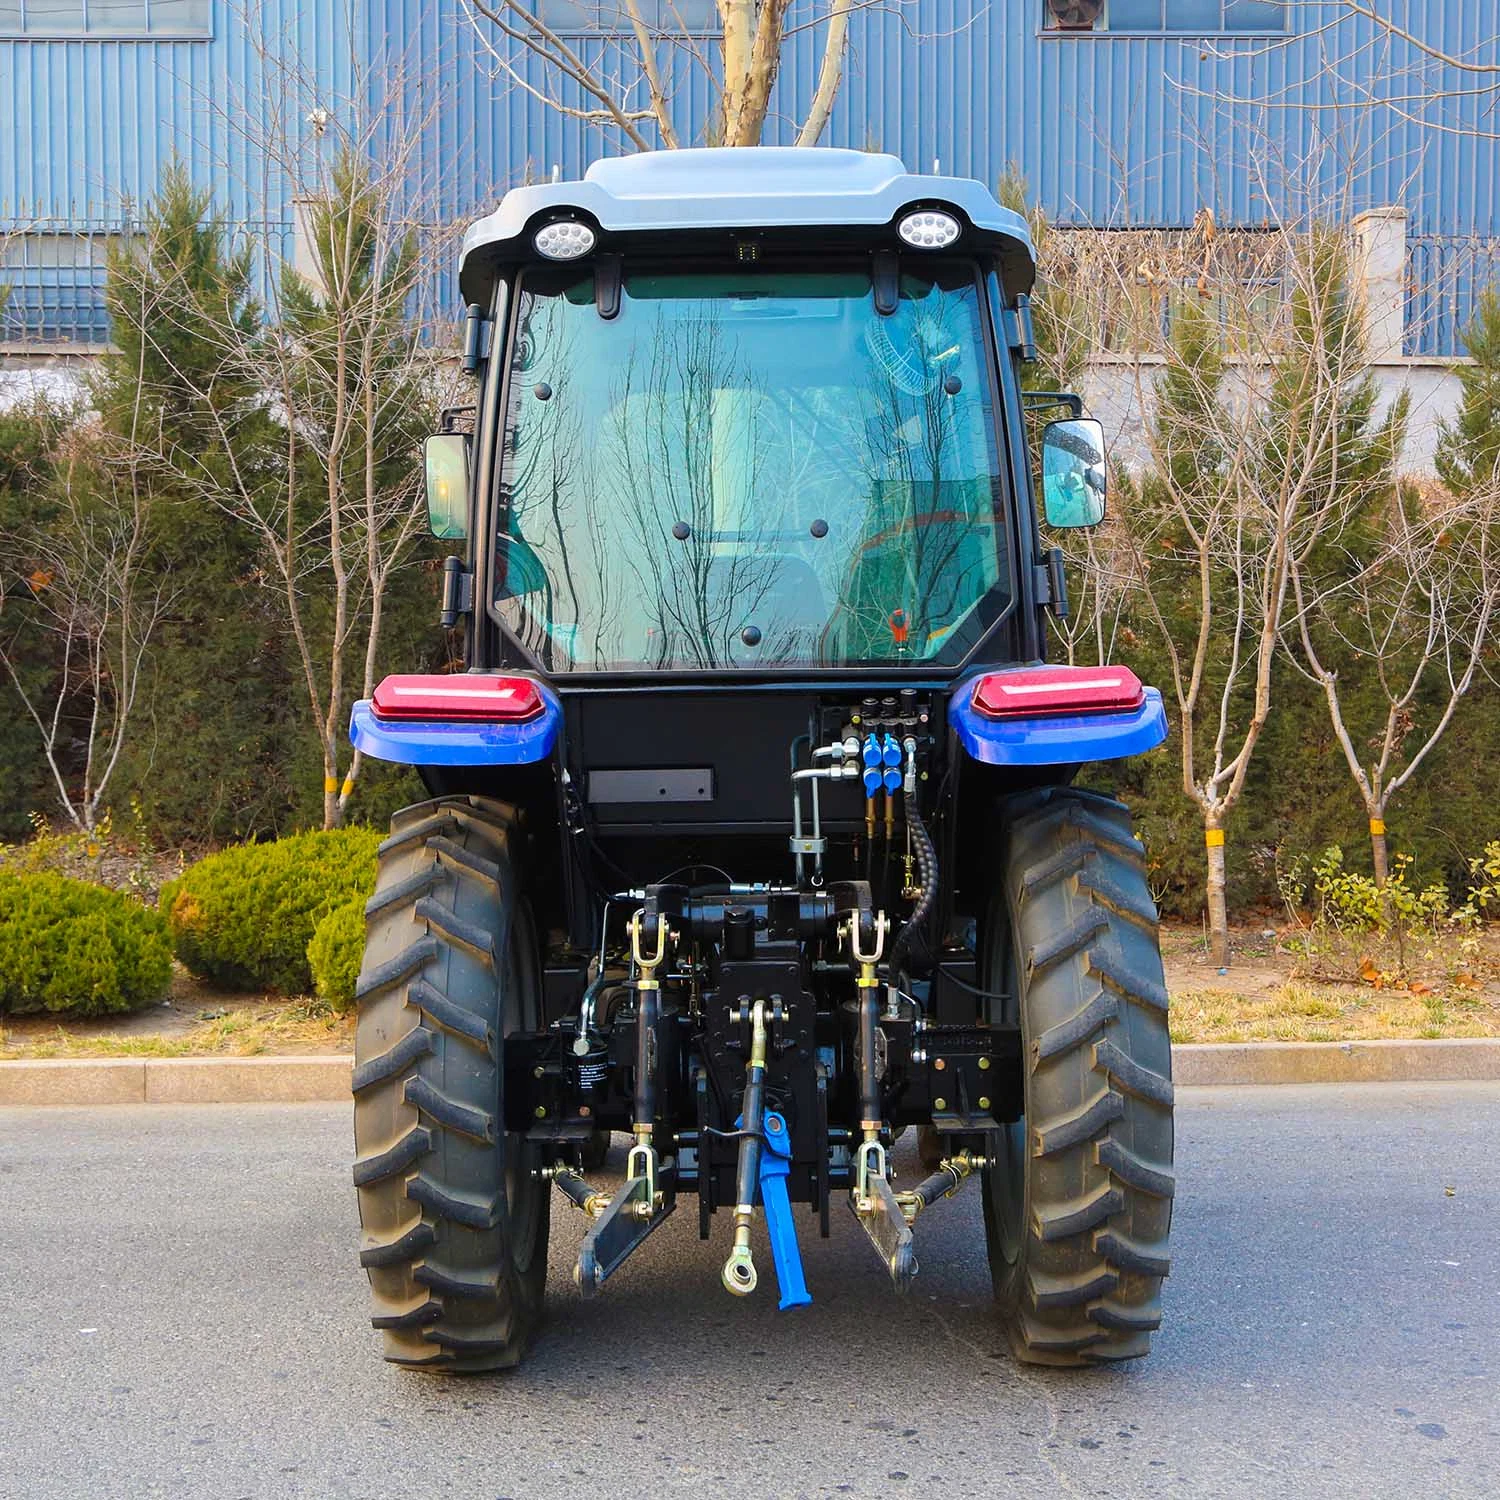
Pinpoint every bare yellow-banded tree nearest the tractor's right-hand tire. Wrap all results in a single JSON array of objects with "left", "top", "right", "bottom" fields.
[{"left": 1127, "top": 228, "right": 1403, "bottom": 968}]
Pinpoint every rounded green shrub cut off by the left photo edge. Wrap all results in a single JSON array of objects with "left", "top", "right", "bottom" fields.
[{"left": 0, "top": 872, "right": 173, "bottom": 1016}]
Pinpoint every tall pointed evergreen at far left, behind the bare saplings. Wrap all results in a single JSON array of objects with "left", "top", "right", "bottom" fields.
[{"left": 93, "top": 165, "right": 305, "bottom": 840}]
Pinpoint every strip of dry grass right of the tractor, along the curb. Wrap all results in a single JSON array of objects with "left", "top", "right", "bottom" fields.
[{"left": 1172, "top": 971, "right": 1500, "bottom": 1043}]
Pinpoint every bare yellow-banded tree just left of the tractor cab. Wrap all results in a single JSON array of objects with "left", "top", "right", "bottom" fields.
[{"left": 185, "top": 168, "right": 443, "bottom": 828}]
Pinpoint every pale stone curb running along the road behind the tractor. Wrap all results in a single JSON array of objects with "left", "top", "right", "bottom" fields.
[{"left": 0, "top": 1037, "right": 1500, "bottom": 1106}]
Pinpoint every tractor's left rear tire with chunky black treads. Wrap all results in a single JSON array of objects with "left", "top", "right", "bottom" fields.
[{"left": 354, "top": 798, "right": 549, "bottom": 1371}]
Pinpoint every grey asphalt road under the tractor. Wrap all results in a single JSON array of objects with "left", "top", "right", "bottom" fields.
[{"left": 0, "top": 1085, "right": 1500, "bottom": 1500}]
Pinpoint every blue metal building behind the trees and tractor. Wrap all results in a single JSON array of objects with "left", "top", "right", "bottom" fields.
[{"left": 0, "top": 0, "right": 1500, "bottom": 356}]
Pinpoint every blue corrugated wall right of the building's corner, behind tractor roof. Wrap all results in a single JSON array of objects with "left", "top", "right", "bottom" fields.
[{"left": 371, "top": 0, "right": 1500, "bottom": 234}]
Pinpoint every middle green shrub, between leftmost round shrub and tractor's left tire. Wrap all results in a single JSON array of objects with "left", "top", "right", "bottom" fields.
[{"left": 161, "top": 828, "right": 380, "bottom": 995}]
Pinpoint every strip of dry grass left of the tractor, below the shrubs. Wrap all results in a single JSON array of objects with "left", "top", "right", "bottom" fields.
[{"left": 0, "top": 1001, "right": 354, "bottom": 1062}]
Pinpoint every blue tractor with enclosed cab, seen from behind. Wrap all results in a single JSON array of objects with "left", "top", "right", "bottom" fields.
[{"left": 351, "top": 147, "right": 1173, "bottom": 1371}]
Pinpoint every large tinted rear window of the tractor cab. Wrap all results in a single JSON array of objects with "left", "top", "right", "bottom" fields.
[{"left": 497, "top": 263, "right": 1011, "bottom": 672}]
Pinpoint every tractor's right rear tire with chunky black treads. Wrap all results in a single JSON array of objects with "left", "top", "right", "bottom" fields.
[{"left": 984, "top": 788, "right": 1173, "bottom": 1365}]
